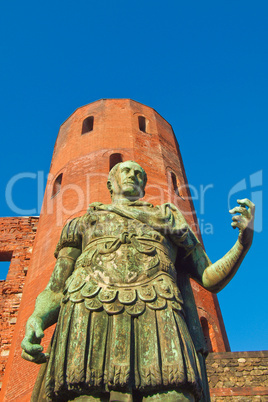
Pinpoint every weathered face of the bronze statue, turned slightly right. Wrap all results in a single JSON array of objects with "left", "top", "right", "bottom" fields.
[{"left": 112, "top": 161, "right": 145, "bottom": 199}]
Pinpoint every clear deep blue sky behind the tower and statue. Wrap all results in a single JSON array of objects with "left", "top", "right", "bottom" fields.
[{"left": 0, "top": 0, "right": 268, "bottom": 351}]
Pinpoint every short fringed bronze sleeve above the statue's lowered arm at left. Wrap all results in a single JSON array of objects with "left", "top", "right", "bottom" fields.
[{"left": 54, "top": 218, "right": 82, "bottom": 258}]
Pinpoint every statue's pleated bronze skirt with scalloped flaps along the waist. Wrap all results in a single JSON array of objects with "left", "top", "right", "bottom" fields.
[{"left": 44, "top": 273, "right": 202, "bottom": 401}]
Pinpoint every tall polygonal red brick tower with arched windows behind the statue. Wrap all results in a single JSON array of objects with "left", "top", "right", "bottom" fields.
[{"left": 2, "top": 99, "right": 229, "bottom": 402}]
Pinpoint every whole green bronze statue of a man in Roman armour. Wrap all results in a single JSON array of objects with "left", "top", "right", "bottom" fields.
[{"left": 22, "top": 161, "right": 254, "bottom": 402}]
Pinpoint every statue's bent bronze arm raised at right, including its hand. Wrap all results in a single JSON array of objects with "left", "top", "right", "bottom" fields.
[{"left": 186, "top": 199, "right": 255, "bottom": 293}]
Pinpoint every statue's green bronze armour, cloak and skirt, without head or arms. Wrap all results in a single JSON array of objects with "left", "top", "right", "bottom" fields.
[{"left": 32, "top": 201, "right": 209, "bottom": 401}]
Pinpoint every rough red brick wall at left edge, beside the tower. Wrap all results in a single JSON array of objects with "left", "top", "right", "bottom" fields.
[{"left": 0, "top": 217, "right": 38, "bottom": 386}]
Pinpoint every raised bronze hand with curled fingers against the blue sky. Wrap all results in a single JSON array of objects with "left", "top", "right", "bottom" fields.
[{"left": 229, "top": 198, "right": 255, "bottom": 248}]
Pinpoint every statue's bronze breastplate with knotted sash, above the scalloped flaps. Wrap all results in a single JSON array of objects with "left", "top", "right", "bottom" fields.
[{"left": 76, "top": 207, "right": 176, "bottom": 284}]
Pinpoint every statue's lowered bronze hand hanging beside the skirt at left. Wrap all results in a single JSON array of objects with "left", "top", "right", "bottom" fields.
[{"left": 21, "top": 316, "right": 49, "bottom": 364}]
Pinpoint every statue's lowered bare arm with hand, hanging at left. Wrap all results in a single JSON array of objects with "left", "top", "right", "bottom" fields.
[{"left": 21, "top": 247, "right": 81, "bottom": 364}]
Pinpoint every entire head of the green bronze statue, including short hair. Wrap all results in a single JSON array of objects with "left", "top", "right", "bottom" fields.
[{"left": 107, "top": 161, "right": 147, "bottom": 201}]
